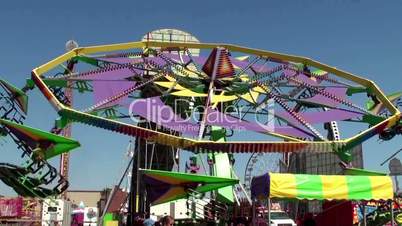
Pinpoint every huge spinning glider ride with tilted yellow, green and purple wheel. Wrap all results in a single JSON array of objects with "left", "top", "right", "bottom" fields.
[{"left": 0, "top": 29, "right": 402, "bottom": 225}]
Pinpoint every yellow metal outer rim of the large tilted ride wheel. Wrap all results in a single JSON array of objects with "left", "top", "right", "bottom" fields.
[{"left": 32, "top": 41, "right": 401, "bottom": 152}]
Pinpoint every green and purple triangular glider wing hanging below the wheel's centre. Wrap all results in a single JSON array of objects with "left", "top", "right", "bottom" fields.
[{"left": 140, "top": 169, "right": 239, "bottom": 205}]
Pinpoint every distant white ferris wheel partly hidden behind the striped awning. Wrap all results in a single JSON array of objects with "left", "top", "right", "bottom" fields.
[{"left": 244, "top": 152, "right": 283, "bottom": 194}]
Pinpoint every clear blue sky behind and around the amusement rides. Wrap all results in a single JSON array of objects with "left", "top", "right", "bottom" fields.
[{"left": 0, "top": 0, "right": 402, "bottom": 195}]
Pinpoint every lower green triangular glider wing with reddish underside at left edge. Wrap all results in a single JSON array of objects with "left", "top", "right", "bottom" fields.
[{"left": 0, "top": 119, "right": 80, "bottom": 159}]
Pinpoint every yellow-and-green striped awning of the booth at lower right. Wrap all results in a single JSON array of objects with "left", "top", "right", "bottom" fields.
[{"left": 251, "top": 173, "right": 394, "bottom": 200}]
